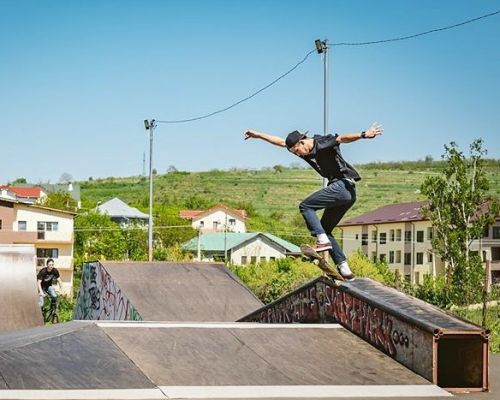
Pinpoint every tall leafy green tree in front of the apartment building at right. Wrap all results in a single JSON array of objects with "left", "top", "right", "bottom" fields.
[{"left": 421, "top": 139, "right": 499, "bottom": 302}]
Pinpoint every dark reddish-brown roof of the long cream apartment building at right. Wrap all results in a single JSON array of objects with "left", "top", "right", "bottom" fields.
[{"left": 338, "top": 201, "right": 427, "bottom": 227}]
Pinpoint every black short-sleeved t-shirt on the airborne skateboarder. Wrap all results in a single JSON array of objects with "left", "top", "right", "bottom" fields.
[{"left": 299, "top": 135, "right": 361, "bottom": 181}]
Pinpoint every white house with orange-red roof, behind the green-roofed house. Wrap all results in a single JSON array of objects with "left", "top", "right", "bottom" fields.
[{"left": 179, "top": 204, "right": 247, "bottom": 233}]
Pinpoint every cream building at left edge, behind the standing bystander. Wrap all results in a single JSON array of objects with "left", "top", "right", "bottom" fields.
[{"left": 0, "top": 199, "right": 76, "bottom": 295}]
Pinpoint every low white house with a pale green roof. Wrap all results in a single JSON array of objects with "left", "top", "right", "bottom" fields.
[{"left": 183, "top": 232, "right": 300, "bottom": 265}]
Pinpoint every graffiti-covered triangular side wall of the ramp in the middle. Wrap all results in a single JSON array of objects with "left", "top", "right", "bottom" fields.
[{"left": 73, "top": 262, "right": 142, "bottom": 321}]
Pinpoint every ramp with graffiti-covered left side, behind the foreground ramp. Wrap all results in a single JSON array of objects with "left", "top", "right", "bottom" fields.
[{"left": 74, "top": 261, "right": 263, "bottom": 322}]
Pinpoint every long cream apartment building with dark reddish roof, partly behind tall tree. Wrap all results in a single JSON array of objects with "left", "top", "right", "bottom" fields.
[{"left": 338, "top": 202, "right": 500, "bottom": 284}]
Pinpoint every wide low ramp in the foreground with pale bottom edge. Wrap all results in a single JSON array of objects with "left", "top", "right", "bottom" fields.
[{"left": 0, "top": 321, "right": 450, "bottom": 399}]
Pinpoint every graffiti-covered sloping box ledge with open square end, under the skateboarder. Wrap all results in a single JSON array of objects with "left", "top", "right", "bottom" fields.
[{"left": 240, "top": 277, "right": 489, "bottom": 392}]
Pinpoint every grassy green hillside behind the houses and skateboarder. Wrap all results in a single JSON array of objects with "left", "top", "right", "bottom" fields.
[{"left": 80, "top": 160, "right": 500, "bottom": 243}]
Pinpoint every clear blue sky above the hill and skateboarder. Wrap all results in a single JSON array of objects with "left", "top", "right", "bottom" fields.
[{"left": 0, "top": 0, "right": 500, "bottom": 183}]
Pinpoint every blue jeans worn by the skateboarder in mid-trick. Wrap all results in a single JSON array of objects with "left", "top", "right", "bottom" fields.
[{"left": 299, "top": 179, "right": 356, "bottom": 265}]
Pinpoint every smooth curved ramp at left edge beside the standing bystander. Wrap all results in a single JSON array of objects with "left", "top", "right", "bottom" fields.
[{"left": 0, "top": 245, "right": 43, "bottom": 332}]
